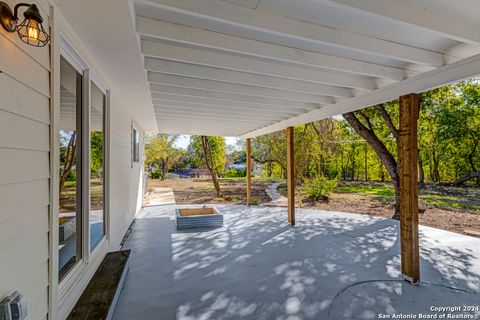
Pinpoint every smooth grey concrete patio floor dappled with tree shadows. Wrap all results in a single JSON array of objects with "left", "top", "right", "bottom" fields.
[{"left": 114, "top": 205, "right": 480, "bottom": 320}]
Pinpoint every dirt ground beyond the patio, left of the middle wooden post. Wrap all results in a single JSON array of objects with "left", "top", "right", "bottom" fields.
[{"left": 148, "top": 178, "right": 272, "bottom": 204}]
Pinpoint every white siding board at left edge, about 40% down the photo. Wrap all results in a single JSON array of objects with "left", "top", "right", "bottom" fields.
[{"left": 0, "top": 110, "right": 50, "bottom": 152}]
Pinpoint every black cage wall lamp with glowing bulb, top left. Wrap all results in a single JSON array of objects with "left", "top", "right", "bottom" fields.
[{"left": 0, "top": 2, "right": 50, "bottom": 47}]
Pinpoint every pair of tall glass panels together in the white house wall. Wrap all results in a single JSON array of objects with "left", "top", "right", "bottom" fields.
[{"left": 58, "top": 55, "right": 108, "bottom": 283}]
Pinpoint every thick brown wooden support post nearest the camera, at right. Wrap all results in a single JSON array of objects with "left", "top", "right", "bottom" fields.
[{"left": 399, "top": 93, "right": 420, "bottom": 284}]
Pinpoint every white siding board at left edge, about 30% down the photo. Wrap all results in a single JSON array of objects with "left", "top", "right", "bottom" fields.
[{"left": 0, "top": 73, "right": 50, "bottom": 124}]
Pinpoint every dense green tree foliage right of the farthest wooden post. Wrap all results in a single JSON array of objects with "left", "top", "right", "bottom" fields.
[{"left": 252, "top": 80, "right": 480, "bottom": 184}]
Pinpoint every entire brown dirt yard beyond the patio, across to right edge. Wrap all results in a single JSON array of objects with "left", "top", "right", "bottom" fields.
[{"left": 148, "top": 178, "right": 480, "bottom": 238}]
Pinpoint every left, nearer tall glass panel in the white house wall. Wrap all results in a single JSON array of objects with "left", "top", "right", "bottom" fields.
[{"left": 58, "top": 57, "right": 83, "bottom": 280}]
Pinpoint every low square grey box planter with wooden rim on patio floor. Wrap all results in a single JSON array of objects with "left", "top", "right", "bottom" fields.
[{"left": 175, "top": 207, "right": 223, "bottom": 230}]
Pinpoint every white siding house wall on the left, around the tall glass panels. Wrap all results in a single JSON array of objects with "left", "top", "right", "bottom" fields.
[{"left": 0, "top": 0, "right": 143, "bottom": 319}]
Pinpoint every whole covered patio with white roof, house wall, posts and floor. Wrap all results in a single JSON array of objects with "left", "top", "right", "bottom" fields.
[{"left": 0, "top": 0, "right": 480, "bottom": 320}]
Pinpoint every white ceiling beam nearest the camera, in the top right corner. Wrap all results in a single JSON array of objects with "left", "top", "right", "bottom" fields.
[{"left": 313, "top": 0, "right": 480, "bottom": 44}]
